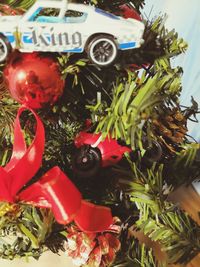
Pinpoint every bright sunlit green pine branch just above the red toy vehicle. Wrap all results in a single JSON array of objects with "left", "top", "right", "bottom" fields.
[{"left": 88, "top": 70, "right": 181, "bottom": 148}]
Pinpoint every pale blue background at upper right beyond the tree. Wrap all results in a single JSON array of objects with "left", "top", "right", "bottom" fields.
[{"left": 143, "top": 0, "right": 200, "bottom": 142}]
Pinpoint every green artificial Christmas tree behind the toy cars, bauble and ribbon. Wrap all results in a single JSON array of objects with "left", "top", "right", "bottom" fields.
[{"left": 0, "top": 0, "right": 200, "bottom": 267}]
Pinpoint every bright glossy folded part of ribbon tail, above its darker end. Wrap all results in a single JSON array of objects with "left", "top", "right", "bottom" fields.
[{"left": 19, "top": 167, "right": 82, "bottom": 224}]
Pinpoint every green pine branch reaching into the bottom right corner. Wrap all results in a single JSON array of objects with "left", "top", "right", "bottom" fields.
[{"left": 119, "top": 165, "right": 200, "bottom": 263}]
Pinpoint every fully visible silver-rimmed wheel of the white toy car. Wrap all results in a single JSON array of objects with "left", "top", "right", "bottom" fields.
[{"left": 87, "top": 35, "right": 118, "bottom": 67}]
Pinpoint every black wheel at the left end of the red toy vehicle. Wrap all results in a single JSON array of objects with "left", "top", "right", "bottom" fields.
[{"left": 72, "top": 145, "right": 101, "bottom": 178}]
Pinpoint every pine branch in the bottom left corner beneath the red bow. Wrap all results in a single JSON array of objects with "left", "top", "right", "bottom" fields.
[{"left": 0, "top": 202, "right": 54, "bottom": 260}]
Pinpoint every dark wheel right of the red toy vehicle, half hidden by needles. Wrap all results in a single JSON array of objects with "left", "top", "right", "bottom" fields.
[{"left": 144, "top": 140, "right": 163, "bottom": 162}]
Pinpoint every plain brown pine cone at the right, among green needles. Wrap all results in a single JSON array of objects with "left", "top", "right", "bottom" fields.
[{"left": 153, "top": 108, "right": 187, "bottom": 152}]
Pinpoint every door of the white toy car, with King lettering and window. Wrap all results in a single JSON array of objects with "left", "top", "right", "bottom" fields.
[{"left": 18, "top": 8, "right": 72, "bottom": 52}]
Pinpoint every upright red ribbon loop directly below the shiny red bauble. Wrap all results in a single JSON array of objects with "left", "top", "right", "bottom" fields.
[{"left": 4, "top": 107, "right": 45, "bottom": 198}]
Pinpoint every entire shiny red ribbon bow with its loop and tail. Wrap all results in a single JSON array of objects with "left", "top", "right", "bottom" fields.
[{"left": 0, "top": 107, "right": 113, "bottom": 232}]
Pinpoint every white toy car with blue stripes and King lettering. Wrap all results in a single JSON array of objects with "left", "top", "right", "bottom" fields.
[{"left": 0, "top": 0, "right": 144, "bottom": 66}]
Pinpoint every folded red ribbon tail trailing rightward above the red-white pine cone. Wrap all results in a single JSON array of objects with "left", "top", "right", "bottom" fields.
[{"left": 19, "top": 167, "right": 113, "bottom": 232}]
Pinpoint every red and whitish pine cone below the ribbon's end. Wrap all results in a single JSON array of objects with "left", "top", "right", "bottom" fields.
[{"left": 66, "top": 218, "right": 121, "bottom": 267}]
